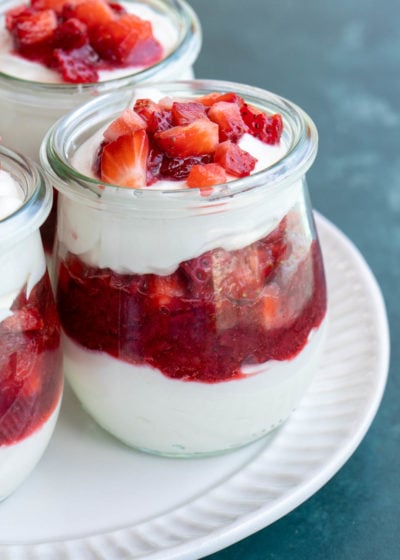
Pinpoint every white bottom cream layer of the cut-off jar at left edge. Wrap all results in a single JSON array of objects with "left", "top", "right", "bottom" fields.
[{"left": 0, "top": 397, "right": 61, "bottom": 501}]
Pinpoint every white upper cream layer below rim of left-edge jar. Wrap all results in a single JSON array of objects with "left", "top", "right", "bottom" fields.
[{"left": 0, "top": 231, "right": 46, "bottom": 321}]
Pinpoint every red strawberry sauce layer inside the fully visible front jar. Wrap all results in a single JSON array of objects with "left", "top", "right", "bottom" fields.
[{"left": 57, "top": 220, "right": 326, "bottom": 383}]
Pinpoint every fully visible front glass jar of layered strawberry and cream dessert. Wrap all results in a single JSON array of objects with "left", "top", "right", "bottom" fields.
[{"left": 41, "top": 81, "right": 326, "bottom": 456}]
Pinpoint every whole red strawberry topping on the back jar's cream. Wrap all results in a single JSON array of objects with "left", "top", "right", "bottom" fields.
[{"left": 6, "top": 0, "right": 164, "bottom": 84}]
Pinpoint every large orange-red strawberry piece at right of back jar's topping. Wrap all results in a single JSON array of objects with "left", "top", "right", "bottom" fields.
[{"left": 91, "top": 14, "right": 163, "bottom": 66}]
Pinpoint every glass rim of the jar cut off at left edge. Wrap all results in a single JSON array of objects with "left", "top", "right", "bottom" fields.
[{"left": 0, "top": 146, "right": 53, "bottom": 248}]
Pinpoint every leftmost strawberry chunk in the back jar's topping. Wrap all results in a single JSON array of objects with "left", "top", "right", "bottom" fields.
[{"left": 13, "top": 10, "right": 57, "bottom": 52}]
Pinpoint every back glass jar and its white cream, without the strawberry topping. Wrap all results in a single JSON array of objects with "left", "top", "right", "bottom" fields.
[{"left": 0, "top": 0, "right": 201, "bottom": 160}]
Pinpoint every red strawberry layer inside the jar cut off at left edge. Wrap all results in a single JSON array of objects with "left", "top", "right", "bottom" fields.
[{"left": 0, "top": 274, "right": 62, "bottom": 446}]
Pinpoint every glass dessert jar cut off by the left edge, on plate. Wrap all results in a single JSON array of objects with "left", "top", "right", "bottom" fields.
[{"left": 0, "top": 147, "right": 63, "bottom": 500}]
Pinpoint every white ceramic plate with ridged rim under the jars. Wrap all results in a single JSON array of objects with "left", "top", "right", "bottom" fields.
[{"left": 0, "top": 216, "right": 389, "bottom": 560}]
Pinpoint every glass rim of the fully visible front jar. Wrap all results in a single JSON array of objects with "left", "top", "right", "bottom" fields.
[{"left": 40, "top": 80, "right": 318, "bottom": 206}]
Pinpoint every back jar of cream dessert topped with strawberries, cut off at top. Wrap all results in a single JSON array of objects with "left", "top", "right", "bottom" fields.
[{"left": 0, "top": 0, "right": 201, "bottom": 160}]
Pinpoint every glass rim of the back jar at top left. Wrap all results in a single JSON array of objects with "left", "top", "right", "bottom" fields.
[{"left": 0, "top": 0, "right": 202, "bottom": 96}]
